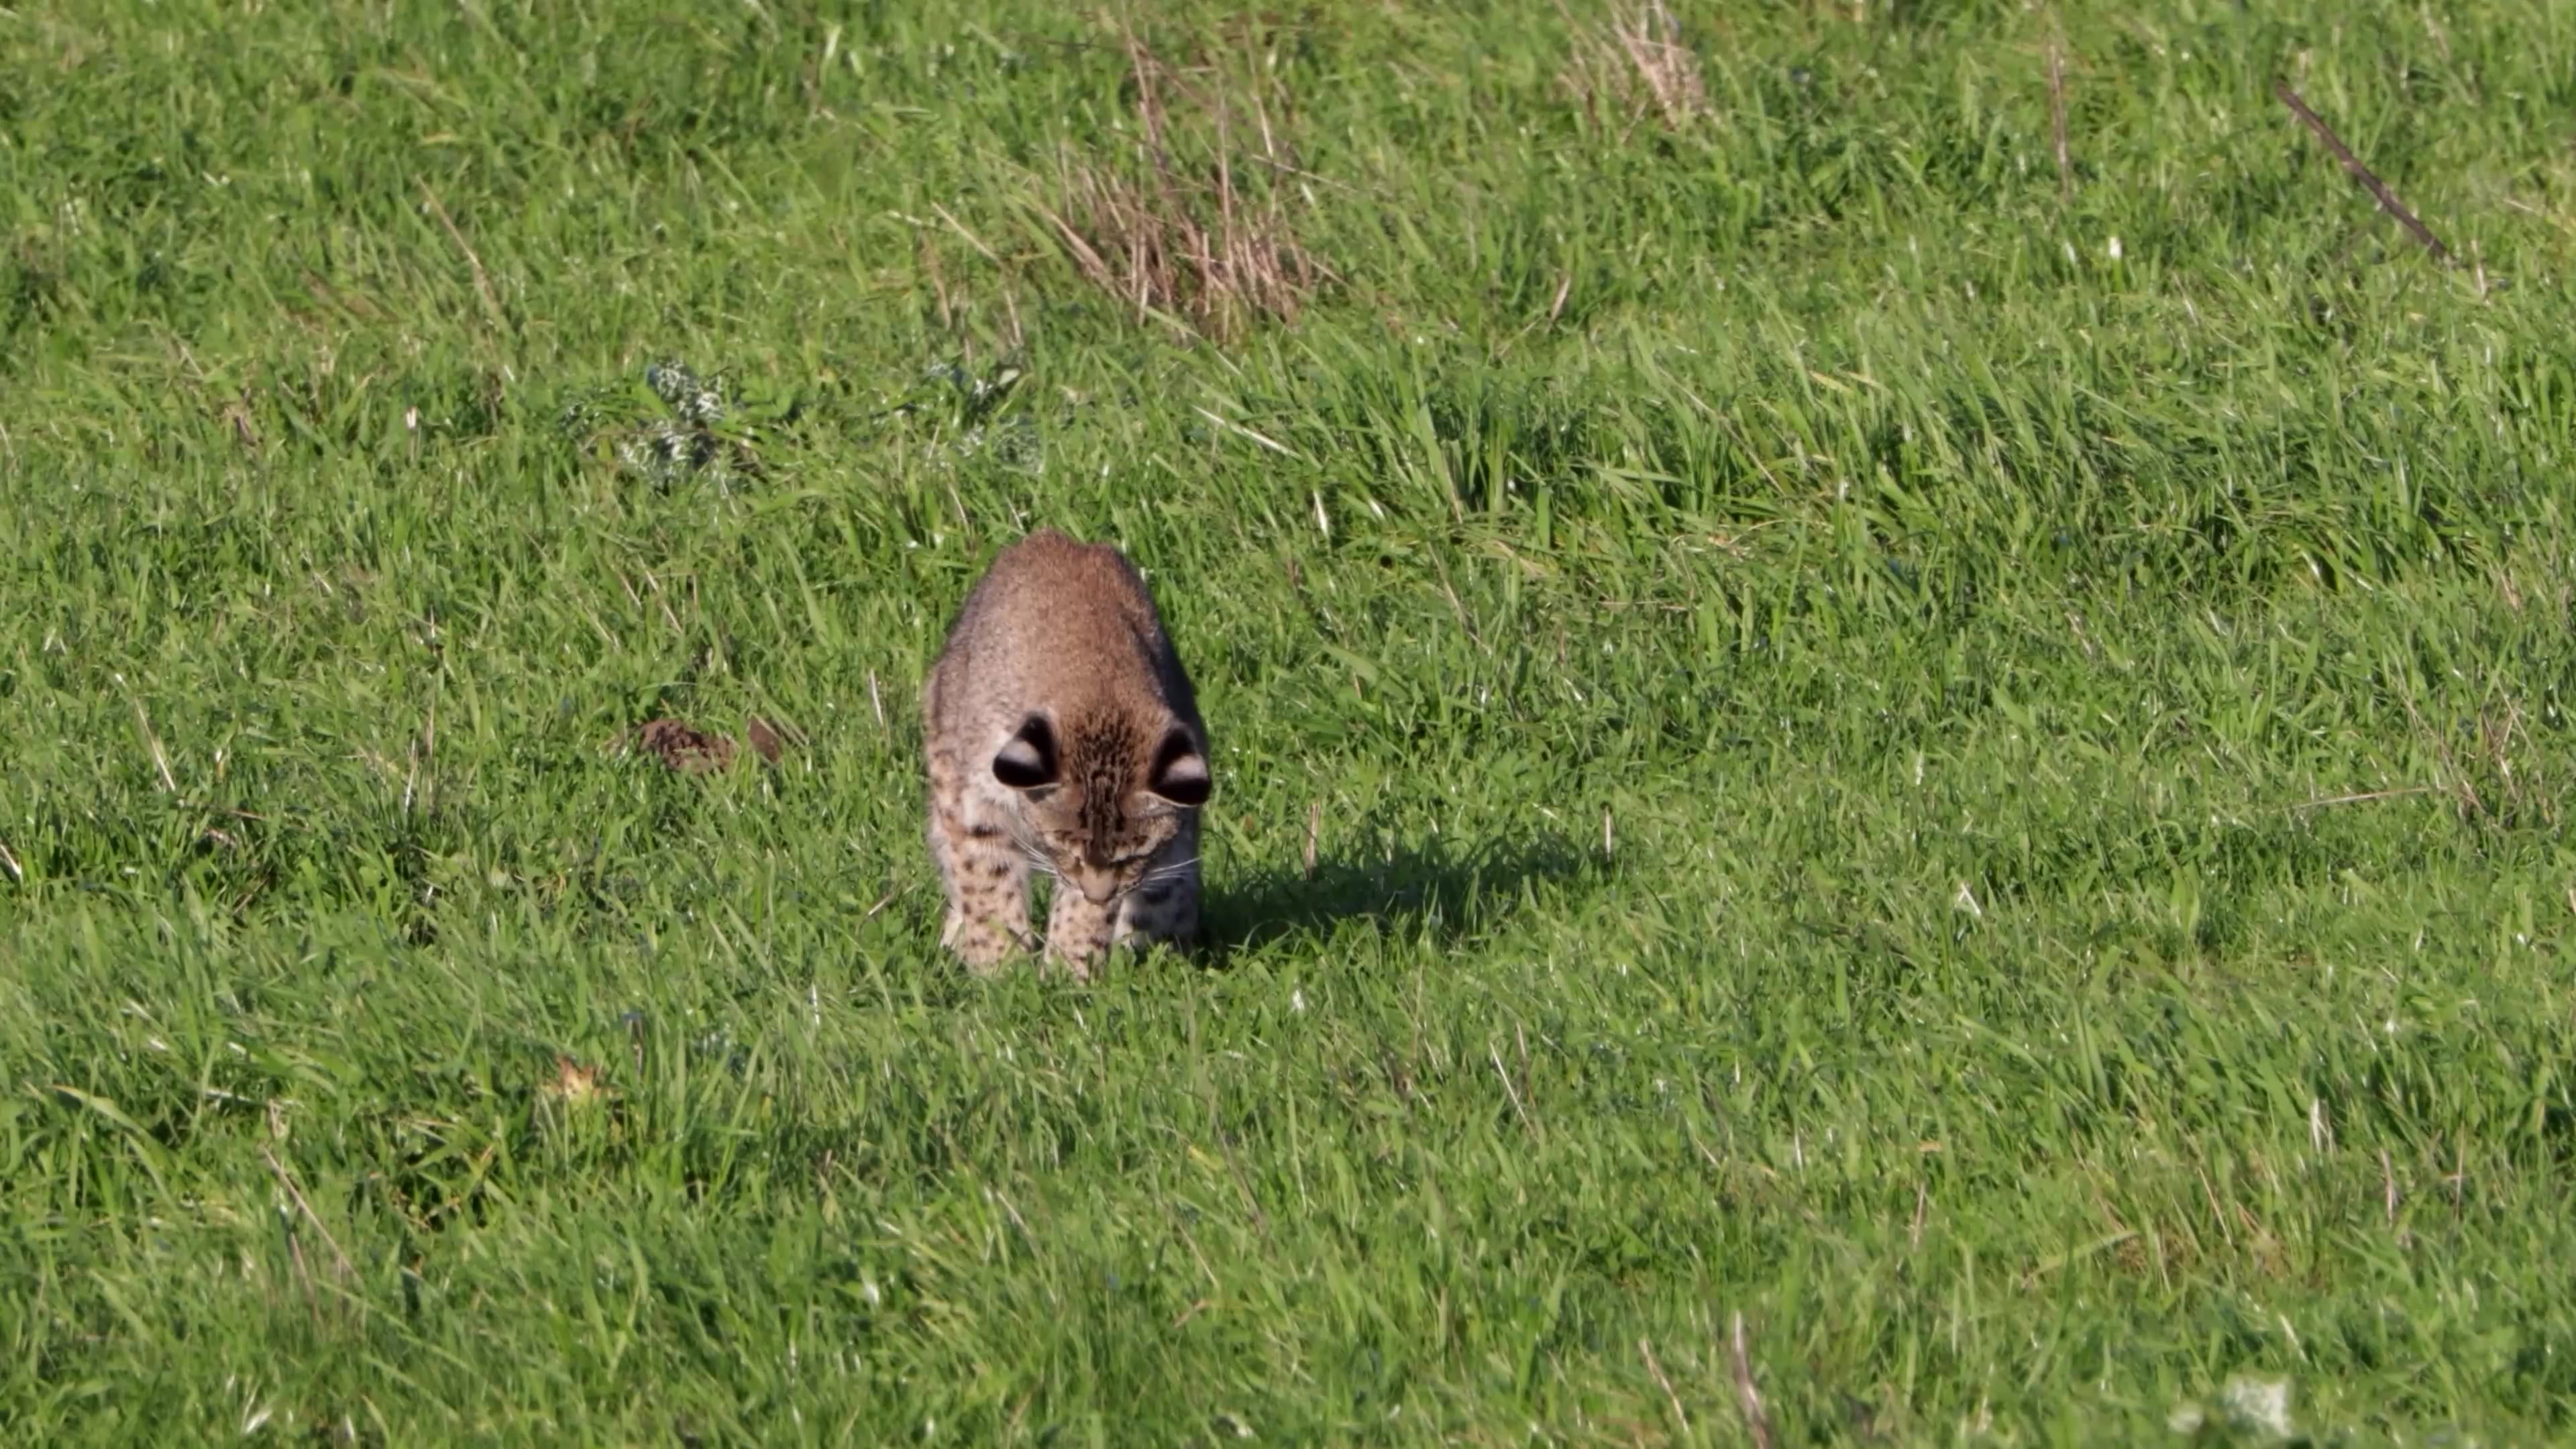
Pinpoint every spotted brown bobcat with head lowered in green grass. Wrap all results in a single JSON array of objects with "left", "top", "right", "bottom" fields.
[{"left": 922, "top": 529, "right": 1211, "bottom": 977}]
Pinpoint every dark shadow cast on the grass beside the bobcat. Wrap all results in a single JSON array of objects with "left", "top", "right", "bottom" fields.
[{"left": 1200, "top": 835, "right": 1602, "bottom": 964}]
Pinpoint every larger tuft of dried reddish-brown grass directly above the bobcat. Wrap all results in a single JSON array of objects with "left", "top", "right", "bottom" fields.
[{"left": 1036, "top": 34, "right": 1337, "bottom": 340}]
